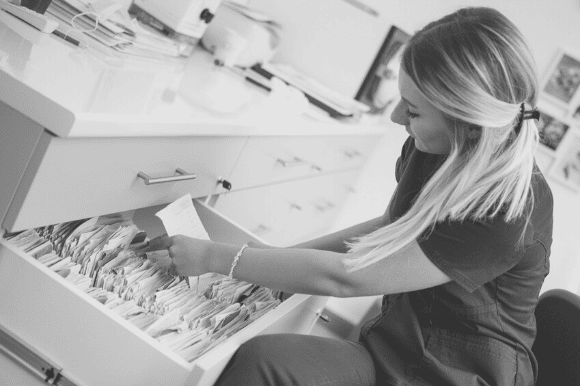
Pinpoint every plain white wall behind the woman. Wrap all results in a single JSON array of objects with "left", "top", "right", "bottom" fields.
[{"left": 249, "top": 0, "right": 580, "bottom": 294}]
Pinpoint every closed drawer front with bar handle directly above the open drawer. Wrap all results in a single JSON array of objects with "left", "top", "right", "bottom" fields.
[{"left": 2, "top": 134, "right": 247, "bottom": 231}]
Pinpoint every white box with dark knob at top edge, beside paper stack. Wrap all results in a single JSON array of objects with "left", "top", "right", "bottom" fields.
[{"left": 129, "top": 0, "right": 221, "bottom": 44}]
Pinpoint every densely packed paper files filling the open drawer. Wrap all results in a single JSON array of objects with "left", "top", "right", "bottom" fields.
[{"left": 4, "top": 215, "right": 280, "bottom": 361}]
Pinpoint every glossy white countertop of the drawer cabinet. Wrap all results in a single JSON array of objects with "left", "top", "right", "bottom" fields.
[{"left": 0, "top": 11, "right": 381, "bottom": 137}]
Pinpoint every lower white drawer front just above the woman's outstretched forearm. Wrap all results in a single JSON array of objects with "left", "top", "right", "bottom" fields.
[{"left": 215, "top": 169, "right": 359, "bottom": 246}]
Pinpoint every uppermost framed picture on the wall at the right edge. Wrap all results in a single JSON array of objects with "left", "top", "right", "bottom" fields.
[{"left": 542, "top": 48, "right": 580, "bottom": 111}]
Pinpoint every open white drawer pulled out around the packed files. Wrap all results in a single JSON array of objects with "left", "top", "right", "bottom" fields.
[{"left": 0, "top": 201, "right": 326, "bottom": 386}]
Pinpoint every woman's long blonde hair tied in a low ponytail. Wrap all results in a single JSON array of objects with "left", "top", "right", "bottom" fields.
[{"left": 346, "top": 7, "right": 538, "bottom": 269}]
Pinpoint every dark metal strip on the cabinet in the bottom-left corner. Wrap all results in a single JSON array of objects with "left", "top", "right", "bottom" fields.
[{"left": 0, "top": 325, "right": 77, "bottom": 386}]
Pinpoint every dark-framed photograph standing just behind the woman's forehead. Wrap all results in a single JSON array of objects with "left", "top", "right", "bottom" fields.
[{"left": 355, "top": 26, "right": 411, "bottom": 115}]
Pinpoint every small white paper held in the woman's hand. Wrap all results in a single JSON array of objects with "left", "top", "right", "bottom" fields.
[{"left": 155, "top": 193, "right": 209, "bottom": 240}]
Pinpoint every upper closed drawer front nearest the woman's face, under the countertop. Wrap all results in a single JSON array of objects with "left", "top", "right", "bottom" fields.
[{"left": 229, "top": 135, "right": 378, "bottom": 190}]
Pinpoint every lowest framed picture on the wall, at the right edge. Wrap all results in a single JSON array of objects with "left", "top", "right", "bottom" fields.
[{"left": 549, "top": 129, "right": 580, "bottom": 192}]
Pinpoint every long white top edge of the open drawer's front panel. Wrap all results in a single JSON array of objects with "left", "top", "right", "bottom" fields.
[{"left": 0, "top": 238, "right": 193, "bottom": 370}]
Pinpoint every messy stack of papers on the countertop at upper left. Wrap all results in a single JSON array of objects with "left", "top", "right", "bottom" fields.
[{"left": 45, "top": 0, "right": 193, "bottom": 59}]
